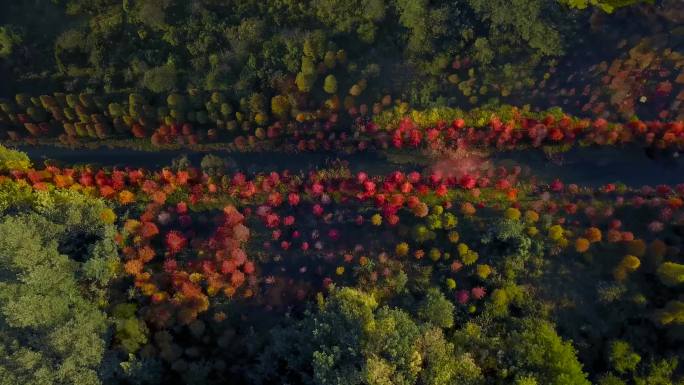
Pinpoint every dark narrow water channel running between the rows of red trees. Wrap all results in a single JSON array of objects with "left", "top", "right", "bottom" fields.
[{"left": 13, "top": 146, "right": 684, "bottom": 187}]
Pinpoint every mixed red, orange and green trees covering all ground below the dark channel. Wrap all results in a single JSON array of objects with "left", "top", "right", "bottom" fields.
[{"left": 0, "top": 143, "right": 684, "bottom": 384}]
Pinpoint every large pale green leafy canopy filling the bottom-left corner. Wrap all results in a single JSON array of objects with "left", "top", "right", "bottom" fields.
[{"left": 0, "top": 214, "right": 107, "bottom": 384}]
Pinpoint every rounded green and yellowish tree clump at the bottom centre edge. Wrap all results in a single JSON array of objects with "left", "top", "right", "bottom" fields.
[{"left": 255, "top": 288, "right": 481, "bottom": 385}]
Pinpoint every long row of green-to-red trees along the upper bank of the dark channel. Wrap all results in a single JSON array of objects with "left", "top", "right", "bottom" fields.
[{"left": 2, "top": 93, "right": 684, "bottom": 151}]
